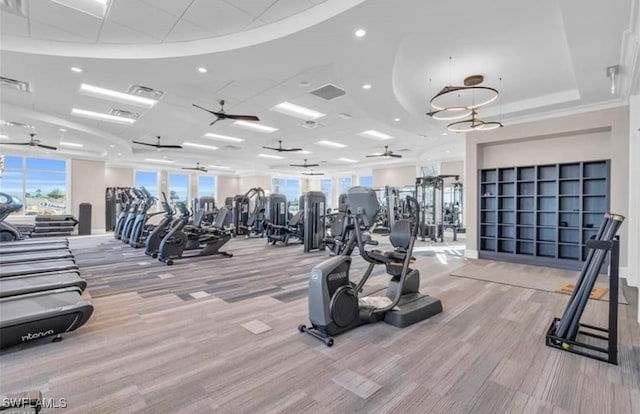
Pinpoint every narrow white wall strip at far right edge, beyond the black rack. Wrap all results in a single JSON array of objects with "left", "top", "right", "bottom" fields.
[{"left": 627, "top": 95, "right": 640, "bottom": 323}]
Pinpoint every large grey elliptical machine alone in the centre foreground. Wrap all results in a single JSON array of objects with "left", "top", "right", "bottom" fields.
[{"left": 298, "top": 187, "right": 442, "bottom": 346}]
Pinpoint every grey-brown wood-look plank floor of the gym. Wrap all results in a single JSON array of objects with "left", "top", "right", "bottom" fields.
[{"left": 0, "top": 236, "right": 640, "bottom": 414}]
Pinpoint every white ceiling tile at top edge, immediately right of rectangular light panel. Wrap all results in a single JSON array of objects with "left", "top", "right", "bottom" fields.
[{"left": 108, "top": 0, "right": 177, "bottom": 39}]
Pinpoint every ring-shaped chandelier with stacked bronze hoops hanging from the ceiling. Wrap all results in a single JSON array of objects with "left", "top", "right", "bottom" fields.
[{"left": 427, "top": 75, "right": 502, "bottom": 132}]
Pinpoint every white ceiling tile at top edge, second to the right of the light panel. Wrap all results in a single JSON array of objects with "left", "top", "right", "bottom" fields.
[{"left": 184, "top": 0, "right": 253, "bottom": 35}]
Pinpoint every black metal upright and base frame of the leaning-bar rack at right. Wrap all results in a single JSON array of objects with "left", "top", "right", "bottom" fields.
[{"left": 546, "top": 237, "right": 620, "bottom": 365}]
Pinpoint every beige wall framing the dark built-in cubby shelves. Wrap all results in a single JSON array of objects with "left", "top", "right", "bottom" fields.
[{"left": 464, "top": 106, "right": 629, "bottom": 270}]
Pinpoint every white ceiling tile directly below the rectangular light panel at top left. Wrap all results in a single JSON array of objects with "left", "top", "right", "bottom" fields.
[{"left": 29, "top": 1, "right": 102, "bottom": 42}]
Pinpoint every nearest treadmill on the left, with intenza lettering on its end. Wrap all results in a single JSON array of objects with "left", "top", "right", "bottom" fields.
[{"left": 0, "top": 287, "right": 93, "bottom": 348}]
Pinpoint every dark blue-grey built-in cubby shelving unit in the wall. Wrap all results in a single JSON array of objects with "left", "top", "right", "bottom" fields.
[{"left": 478, "top": 160, "right": 610, "bottom": 268}]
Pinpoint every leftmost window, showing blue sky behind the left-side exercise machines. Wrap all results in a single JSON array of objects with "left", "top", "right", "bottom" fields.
[{"left": 0, "top": 155, "right": 67, "bottom": 215}]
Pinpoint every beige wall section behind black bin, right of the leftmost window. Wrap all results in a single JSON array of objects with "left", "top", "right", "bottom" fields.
[{"left": 71, "top": 160, "right": 107, "bottom": 233}]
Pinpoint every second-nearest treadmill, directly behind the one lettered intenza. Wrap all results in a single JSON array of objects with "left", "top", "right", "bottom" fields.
[{"left": 0, "top": 271, "right": 87, "bottom": 298}]
